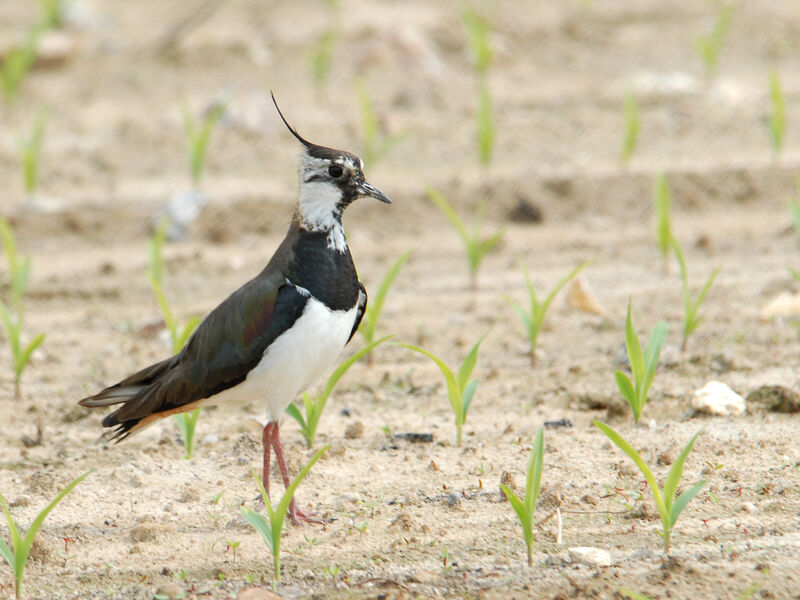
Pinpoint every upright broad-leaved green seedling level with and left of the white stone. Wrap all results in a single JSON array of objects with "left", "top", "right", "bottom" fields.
[{"left": 614, "top": 300, "right": 669, "bottom": 423}]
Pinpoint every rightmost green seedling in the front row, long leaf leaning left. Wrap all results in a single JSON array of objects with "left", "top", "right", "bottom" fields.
[{"left": 592, "top": 421, "right": 706, "bottom": 554}]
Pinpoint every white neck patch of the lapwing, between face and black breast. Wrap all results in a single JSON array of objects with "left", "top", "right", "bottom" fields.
[{"left": 295, "top": 181, "right": 347, "bottom": 252}]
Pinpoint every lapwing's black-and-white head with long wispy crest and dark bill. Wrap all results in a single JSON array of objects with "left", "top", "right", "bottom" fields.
[{"left": 272, "top": 95, "right": 391, "bottom": 230}]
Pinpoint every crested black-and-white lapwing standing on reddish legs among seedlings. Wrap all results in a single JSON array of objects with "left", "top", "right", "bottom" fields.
[{"left": 78, "top": 94, "right": 391, "bottom": 524}]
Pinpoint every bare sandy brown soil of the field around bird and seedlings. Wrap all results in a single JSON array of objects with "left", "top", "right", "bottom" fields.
[{"left": 0, "top": 0, "right": 800, "bottom": 600}]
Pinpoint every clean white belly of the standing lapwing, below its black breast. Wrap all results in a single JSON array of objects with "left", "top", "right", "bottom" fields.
[{"left": 209, "top": 297, "right": 357, "bottom": 421}]
